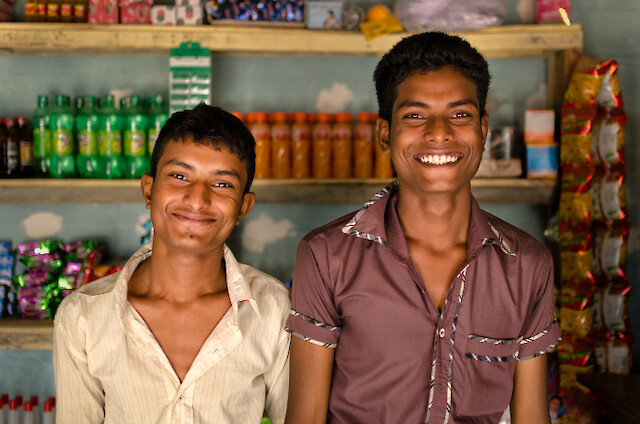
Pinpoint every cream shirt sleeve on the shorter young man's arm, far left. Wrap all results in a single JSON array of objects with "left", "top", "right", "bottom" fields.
[{"left": 53, "top": 308, "right": 104, "bottom": 424}]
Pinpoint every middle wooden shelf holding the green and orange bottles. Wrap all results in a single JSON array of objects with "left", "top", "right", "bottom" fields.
[{"left": 0, "top": 178, "right": 556, "bottom": 204}]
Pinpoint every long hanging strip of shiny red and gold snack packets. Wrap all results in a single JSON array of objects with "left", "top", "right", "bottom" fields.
[{"left": 547, "top": 57, "right": 633, "bottom": 419}]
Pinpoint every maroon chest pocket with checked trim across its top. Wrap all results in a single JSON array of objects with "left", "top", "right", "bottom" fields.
[{"left": 457, "top": 335, "right": 520, "bottom": 417}]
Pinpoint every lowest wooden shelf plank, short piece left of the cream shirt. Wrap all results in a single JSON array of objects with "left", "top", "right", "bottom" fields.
[{"left": 0, "top": 318, "right": 53, "bottom": 350}]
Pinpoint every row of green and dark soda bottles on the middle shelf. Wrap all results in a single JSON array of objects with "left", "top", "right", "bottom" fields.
[{"left": 0, "top": 94, "right": 169, "bottom": 179}]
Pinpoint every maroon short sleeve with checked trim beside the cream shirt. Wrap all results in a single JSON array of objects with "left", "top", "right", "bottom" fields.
[{"left": 286, "top": 239, "right": 342, "bottom": 347}]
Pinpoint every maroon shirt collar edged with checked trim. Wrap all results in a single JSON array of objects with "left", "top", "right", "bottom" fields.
[{"left": 342, "top": 180, "right": 516, "bottom": 256}]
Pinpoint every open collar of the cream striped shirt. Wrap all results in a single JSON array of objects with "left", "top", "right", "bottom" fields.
[{"left": 114, "top": 239, "right": 262, "bottom": 321}]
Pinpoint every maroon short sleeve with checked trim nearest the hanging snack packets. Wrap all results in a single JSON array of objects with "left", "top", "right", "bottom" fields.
[{"left": 518, "top": 248, "right": 562, "bottom": 360}]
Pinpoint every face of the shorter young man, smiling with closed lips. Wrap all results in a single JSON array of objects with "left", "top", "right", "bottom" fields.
[{"left": 142, "top": 141, "right": 255, "bottom": 255}]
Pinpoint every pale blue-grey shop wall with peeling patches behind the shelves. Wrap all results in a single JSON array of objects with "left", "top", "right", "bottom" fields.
[{"left": 0, "top": 0, "right": 640, "bottom": 396}]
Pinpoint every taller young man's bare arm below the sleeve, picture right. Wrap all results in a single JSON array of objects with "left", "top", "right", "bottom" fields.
[{"left": 511, "top": 355, "right": 551, "bottom": 424}]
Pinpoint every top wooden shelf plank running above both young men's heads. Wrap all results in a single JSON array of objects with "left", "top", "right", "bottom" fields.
[{"left": 0, "top": 22, "right": 582, "bottom": 57}]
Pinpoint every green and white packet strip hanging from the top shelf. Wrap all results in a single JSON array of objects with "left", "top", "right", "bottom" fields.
[{"left": 169, "top": 43, "right": 211, "bottom": 113}]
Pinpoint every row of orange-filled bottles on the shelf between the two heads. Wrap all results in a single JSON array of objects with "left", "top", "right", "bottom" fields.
[{"left": 244, "top": 112, "right": 394, "bottom": 178}]
